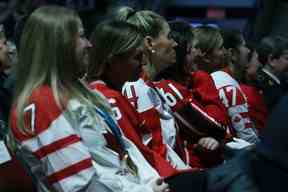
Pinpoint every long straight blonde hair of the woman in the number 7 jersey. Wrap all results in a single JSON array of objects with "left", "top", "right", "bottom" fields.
[{"left": 14, "top": 6, "right": 110, "bottom": 134}]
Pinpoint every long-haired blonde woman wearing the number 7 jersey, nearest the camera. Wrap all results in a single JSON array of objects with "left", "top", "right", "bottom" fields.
[{"left": 10, "top": 6, "right": 168, "bottom": 192}]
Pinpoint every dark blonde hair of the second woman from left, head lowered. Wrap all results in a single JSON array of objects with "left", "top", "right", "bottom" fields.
[{"left": 88, "top": 20, "right": 143, "bottom": 80}]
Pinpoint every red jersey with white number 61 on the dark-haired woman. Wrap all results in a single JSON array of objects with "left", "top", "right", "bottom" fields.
[{"left": 154, "top": 71, "right": 229, "bottom": 168}]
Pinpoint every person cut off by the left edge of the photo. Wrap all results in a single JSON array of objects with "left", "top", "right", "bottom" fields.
[{"left": 0, "top": 21, "right": 35, "bottom": 191}]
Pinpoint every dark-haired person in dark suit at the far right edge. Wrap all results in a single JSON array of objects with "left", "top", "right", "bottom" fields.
[{"left": 252, "top": 36, "right": 288, "bottom": 109}]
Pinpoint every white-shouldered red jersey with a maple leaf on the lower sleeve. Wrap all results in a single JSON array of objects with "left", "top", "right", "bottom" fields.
[{"left": 211, "top": 71, "right": 259, "bottom": 143}]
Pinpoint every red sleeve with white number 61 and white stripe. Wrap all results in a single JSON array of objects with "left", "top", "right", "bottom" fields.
[{"left": 155, "top": 80, "right": 227, "bottom": 138}]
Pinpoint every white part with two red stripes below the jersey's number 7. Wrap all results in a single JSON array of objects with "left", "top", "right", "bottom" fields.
[{"left": 21, "top": 111, "right": 96, "bottom": 192}]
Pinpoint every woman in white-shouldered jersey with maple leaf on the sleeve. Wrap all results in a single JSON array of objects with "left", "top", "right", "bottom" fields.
[{"left": 193, "top": 25, "right": 259, "bottom": 146}]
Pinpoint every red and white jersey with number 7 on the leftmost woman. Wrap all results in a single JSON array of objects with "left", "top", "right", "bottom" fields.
[{"left": 11, "top": 86, "right": 159, "bottom": 192}]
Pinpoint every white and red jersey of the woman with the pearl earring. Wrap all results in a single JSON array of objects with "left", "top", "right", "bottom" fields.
[{"left": 122, "top": 79, "right": 187, "bottom": 169}]
